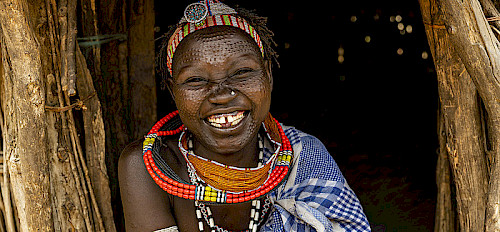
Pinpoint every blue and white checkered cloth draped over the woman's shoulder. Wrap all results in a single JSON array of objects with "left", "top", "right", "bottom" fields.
[{"left": 260, "top": 126, "right": 371, "bottom": 232}]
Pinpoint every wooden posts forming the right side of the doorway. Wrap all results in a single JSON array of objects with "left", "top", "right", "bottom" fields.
[{"left": 420, "top": 0, "right": 500, "bottom": 231}]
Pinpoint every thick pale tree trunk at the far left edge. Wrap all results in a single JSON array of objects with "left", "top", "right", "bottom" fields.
[{"left": 0, "top": 0, "right": 54, "bottom": 231}]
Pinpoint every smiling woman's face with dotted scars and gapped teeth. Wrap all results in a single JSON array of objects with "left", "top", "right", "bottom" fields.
[{"left": 169, "top": 26, "right": 272, "bottom": 154}]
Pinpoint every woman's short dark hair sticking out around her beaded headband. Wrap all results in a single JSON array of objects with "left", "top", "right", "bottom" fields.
[{"left": 156, "top": 6, "right": 279, "bottom": 84}]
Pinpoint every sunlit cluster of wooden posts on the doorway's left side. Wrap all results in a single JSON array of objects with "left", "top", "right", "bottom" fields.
[{"left": 0, "top": 0, "right": 115, "bottom": 231}]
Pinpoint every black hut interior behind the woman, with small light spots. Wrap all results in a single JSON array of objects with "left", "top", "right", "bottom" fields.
[{"left": 155, "top": 0, "right": 438, "bottom": 231}]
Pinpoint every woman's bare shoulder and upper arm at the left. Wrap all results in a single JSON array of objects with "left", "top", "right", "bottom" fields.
[{"left": 118, "top": 140, "right": 175, "bottom": 231}]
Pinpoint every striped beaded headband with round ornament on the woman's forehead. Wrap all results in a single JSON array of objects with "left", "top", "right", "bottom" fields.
[{"left": 167, "top": 0, "right": 264, "bottom": 75}]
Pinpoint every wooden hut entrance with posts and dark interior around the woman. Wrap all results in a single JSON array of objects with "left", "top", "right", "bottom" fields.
[{"left": 0, "top": 0, "right": 500, "bottom": 231}]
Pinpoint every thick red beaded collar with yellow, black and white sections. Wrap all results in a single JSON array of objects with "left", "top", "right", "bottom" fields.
[{"left": 143, "top": 111, "right": 293, "bottom": 204}]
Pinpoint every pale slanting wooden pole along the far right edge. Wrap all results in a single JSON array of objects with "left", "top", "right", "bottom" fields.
[{"left": 441, "top": 0, "right": 500, "bottom": 231}]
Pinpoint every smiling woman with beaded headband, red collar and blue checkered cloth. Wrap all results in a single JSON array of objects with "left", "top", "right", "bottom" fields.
[{"left": 119, "top": 0, "right": 370, "bottom": 231}]
